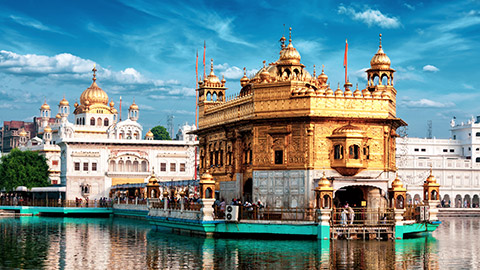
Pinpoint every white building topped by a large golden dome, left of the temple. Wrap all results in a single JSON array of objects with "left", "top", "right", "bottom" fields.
[{"left": 20, "top": 68, "right": 197, "bottom": 199}]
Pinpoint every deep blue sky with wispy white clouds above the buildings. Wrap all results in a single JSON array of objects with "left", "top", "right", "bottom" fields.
[{"left": 0, "top": 0, "right": 480, "bottom": 138}]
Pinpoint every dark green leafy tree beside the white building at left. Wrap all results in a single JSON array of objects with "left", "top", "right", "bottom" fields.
[{"left": 0, "top": 149, "right": 50, "bottom": 191}]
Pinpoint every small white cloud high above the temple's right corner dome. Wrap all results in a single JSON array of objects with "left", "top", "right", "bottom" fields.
[{"left": 338, "top": 5, "right": 401, "bottom": 28}]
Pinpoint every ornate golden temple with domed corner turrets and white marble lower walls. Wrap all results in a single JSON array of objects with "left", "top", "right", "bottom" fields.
[{"left": 197, "top": 28, "right": 405, "bottom": 207}]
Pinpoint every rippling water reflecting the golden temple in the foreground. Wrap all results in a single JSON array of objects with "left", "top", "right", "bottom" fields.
[{"left": 0, "top": 217, "right": 480, "bottom": 270}]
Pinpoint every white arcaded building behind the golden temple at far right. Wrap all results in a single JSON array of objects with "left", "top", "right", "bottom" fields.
[{"left": 397, "top": 116, "right": 480, "bottom": 207}]
